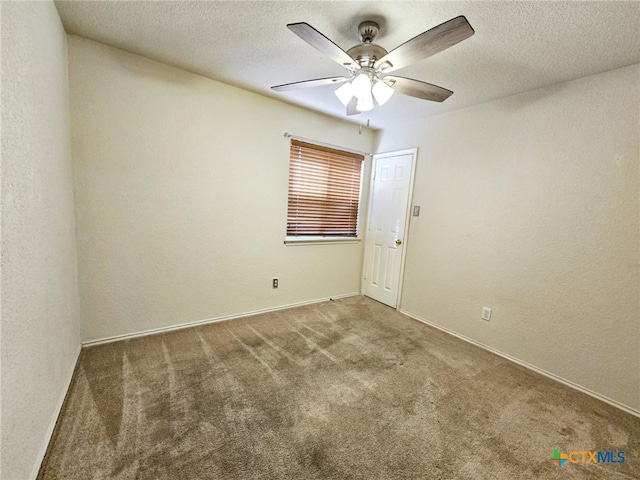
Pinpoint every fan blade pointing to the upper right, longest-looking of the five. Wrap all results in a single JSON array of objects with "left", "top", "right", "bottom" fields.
[{"left": 373, "top": 15, "right": 475, "bottom": 73}]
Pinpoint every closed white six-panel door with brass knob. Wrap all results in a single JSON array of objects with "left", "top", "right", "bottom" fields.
[{"left": 363, "top": 149, "right": 416, "bottom": 308}]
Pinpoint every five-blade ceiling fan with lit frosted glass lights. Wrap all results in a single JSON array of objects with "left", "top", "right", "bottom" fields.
[{"left": 271, "top": 15, "right": 474, "bottom": 115}]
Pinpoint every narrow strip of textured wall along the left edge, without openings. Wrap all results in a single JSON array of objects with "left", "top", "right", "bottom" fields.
[{"left": 0, "top": 2, "right": 80, "bottom": 480}]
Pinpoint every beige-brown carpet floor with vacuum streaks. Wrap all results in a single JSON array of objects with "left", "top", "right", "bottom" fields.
[{"left": 38, "top": 297, "right": 640, "bottom": 480}]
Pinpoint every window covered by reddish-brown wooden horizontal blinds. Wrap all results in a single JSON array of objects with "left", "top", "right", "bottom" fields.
[{"left": 287, "top": 140, "right": 364, "bottom": 239}]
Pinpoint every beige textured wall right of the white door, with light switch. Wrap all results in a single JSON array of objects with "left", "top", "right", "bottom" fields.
[{"left": 379, "top": 65, "right": 640, "bottom": 411}]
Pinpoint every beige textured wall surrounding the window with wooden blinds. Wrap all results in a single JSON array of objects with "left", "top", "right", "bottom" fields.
[{"left": 69, "top": 36, "right": 374, "bottom": 341}]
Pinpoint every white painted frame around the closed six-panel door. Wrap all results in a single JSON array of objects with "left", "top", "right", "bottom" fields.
[{"left": 360, "top": 147, "right": 418, "bottom": 311}]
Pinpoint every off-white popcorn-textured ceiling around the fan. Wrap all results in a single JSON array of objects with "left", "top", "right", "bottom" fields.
[{"left": 56, "top": 1, "right": 640, "bottom": 128}]
